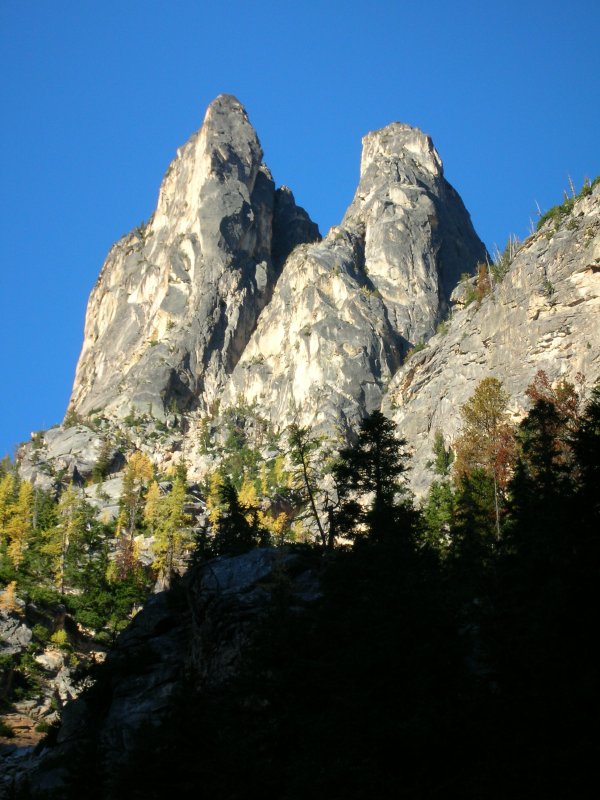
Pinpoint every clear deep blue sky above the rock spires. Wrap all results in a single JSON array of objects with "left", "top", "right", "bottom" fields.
[{"left": 0, "top": 0, "right": 600, "bottom": 455}]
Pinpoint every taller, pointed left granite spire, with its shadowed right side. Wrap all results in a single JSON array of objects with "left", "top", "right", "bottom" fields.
[{"left": 71, "top": 95, "right": 319, "bottom": 417}]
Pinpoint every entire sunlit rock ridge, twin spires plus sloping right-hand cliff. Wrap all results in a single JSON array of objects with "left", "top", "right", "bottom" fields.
[{"left": 14, "top": 95, "right": 600, "bottom": 495}]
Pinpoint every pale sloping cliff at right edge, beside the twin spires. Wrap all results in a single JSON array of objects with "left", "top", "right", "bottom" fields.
[{"left": 384, "top": 185, "right": 600, "bottom": 491}]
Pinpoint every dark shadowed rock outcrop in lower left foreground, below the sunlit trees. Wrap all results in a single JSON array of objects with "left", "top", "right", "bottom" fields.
[{"left": 19, "top": 549, "right": 320, "bottom": 797}]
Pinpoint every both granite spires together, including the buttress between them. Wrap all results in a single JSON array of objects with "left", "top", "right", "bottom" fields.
[{"left": 70, "top": 101, "right": 485, "bottom": 438}]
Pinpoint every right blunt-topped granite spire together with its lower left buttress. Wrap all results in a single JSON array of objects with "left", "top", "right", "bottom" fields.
[{"left": 224, "top": 123, "right": 486, "bottom": 432}]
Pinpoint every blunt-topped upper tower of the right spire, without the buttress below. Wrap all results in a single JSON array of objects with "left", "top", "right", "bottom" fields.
[{"left": 342, "top": 122, "right": 486, "bottom": 343}]
